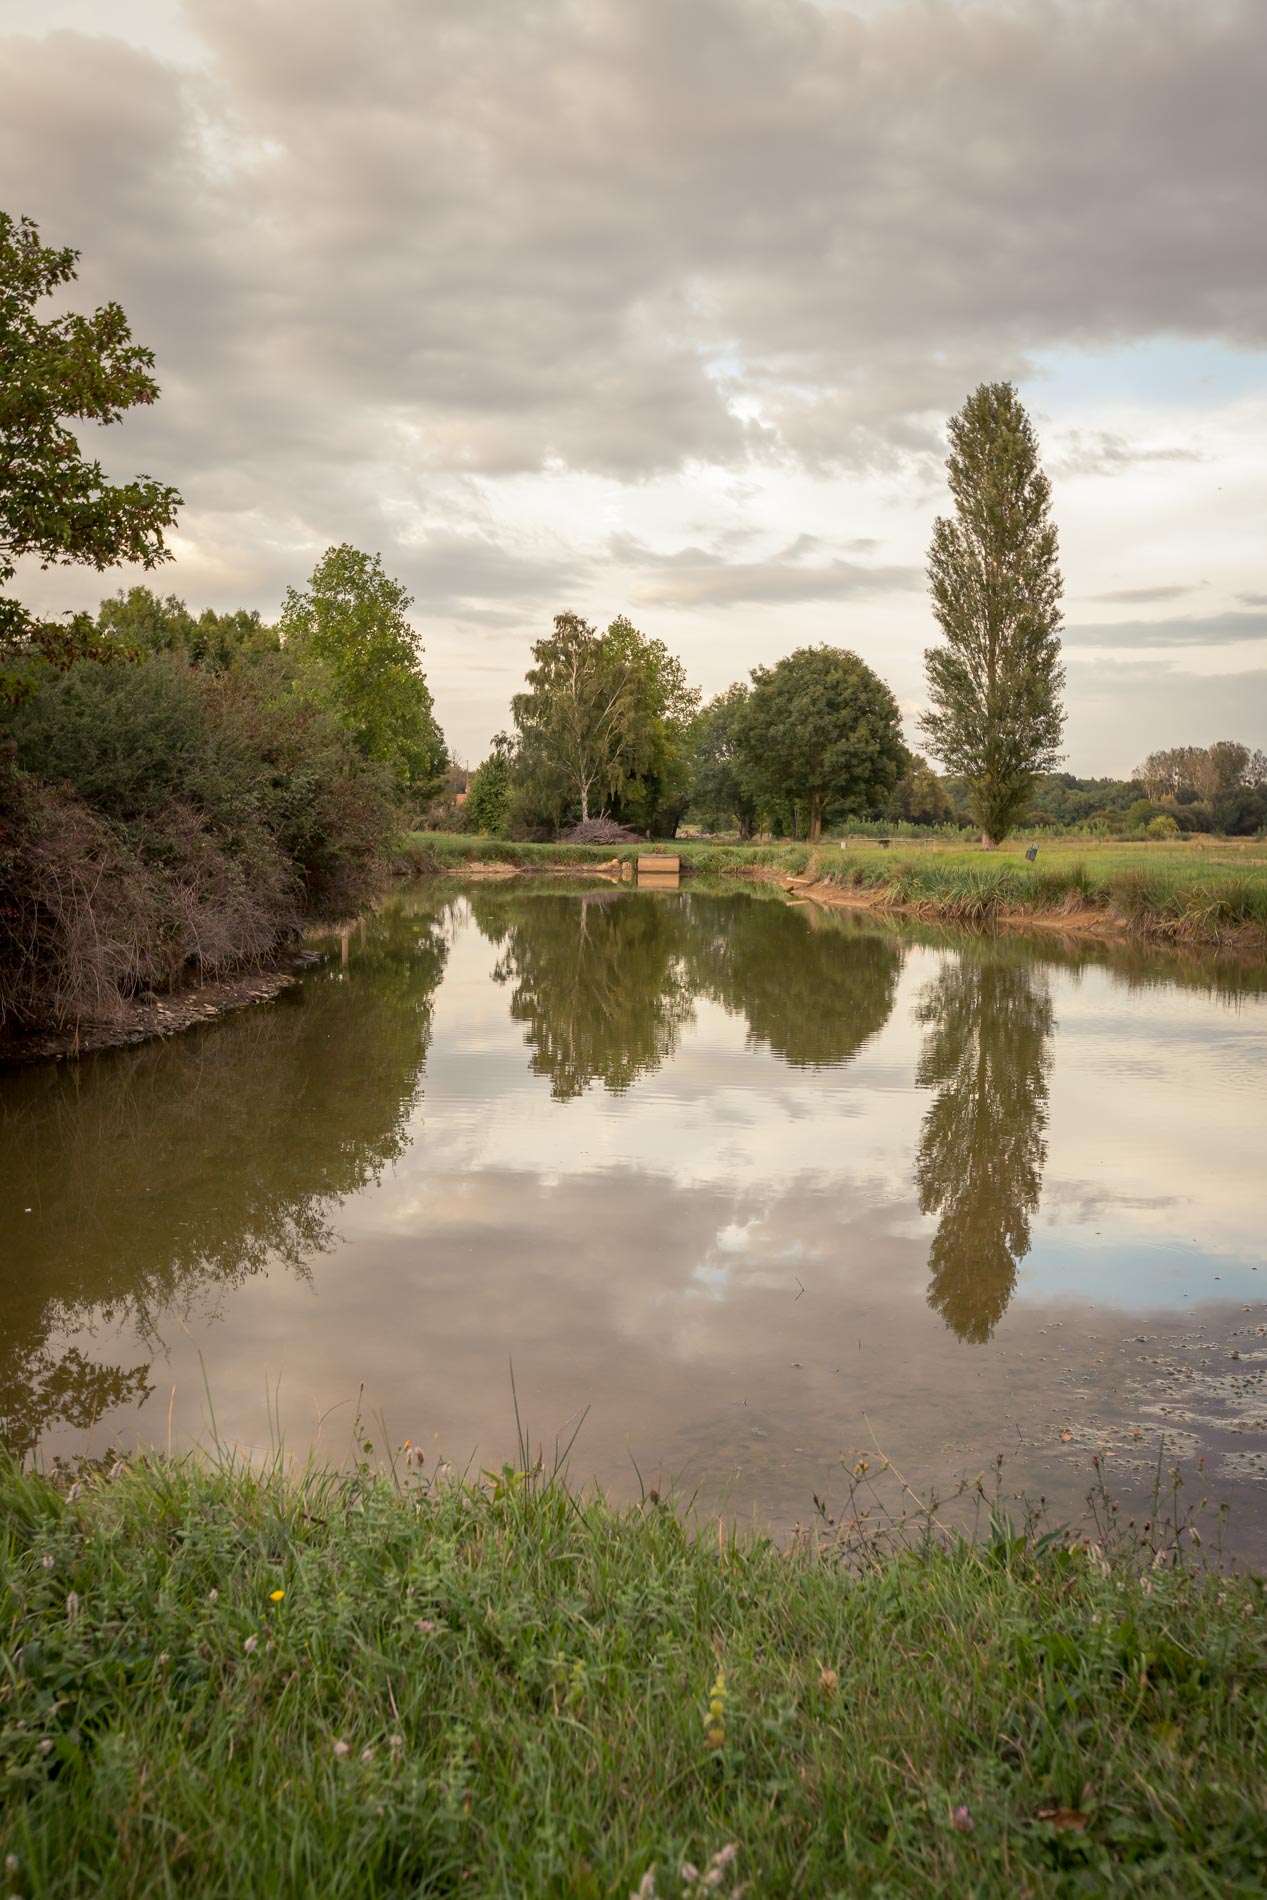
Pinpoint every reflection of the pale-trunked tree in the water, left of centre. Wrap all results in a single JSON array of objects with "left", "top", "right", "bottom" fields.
[{"left": 471, "top": 891, "right": 691, "bottom": 1102}]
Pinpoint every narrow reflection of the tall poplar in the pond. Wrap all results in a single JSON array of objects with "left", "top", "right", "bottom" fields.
[{"left": 916, "top": 944, "right": 1054, "bottom": 1343}]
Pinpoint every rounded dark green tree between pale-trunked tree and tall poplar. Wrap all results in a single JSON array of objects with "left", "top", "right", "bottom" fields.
[{"left": 739, "top": 646, "right": 906, "bottom": 844}]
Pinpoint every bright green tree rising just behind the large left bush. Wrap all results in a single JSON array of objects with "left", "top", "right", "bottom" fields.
[{"left": 279, "top": 542, "right": 448, "bottom": 792}]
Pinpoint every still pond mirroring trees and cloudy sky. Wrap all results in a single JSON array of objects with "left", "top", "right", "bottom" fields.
[{"left": 0, "top": 880, "right": 1267, "bottom": 1558}]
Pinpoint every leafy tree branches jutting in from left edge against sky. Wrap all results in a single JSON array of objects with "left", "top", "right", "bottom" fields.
[{"left": 0, "top": 211, "right": 180, "bottom": 701}]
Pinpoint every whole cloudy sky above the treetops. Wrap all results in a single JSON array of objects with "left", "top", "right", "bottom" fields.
[{"left": 0, "top": 0, "right": 1267, "bottom": 773}]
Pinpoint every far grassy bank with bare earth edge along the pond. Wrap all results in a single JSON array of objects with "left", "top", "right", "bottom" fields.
[{"left": 405, "top": 832, "right": 1267, "bottom": 954}]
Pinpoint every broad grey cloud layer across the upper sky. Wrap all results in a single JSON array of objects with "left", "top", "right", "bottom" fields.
[{"left": 0, "top": 0, "right": 1267, "bottom": 492}]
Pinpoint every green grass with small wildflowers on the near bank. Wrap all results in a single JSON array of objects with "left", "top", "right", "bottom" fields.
[{"left": 0, "top": 1459, "right": 1267, "bottom": 1900}]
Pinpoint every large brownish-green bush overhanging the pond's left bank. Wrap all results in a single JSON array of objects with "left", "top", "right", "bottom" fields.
[{"left": 0, "top": 656, "right": 395, "bottom": 1026}]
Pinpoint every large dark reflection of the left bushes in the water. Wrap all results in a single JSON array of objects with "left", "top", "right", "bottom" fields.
[{"left": 0, "top": 906, "right": 446, "bottom": 1455}]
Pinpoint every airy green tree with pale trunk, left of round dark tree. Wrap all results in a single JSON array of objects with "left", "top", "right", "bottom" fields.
[{"left": 511, "top": 614, "right": 697, "bottom": 827}]
